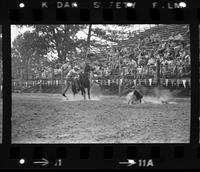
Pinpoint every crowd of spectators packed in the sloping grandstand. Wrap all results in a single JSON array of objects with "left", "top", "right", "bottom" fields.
[{"left": 93, "top": 29, "right": 191, "bottom": 79}]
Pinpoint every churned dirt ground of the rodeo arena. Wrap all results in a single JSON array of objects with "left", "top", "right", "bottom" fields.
[{"left": 12, "top": 89, "right": 190, "bottom": 143}]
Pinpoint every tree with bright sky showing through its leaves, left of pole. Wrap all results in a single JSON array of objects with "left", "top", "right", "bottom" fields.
[{"left": 33, "top": 25, "right": 85, "bottom": 64}]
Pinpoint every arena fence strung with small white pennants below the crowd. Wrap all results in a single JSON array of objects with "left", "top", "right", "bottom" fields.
[{"left": 12, "top": 78, "right": 191, "bottom": 91}]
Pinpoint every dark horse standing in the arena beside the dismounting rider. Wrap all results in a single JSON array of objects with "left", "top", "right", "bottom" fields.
[{"left": 72, "top": 65, "right": 94, "bottom": 100}]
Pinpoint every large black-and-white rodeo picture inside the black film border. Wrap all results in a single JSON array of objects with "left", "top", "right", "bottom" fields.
[{"left": 11, "top": 24, "right": 191, "bottom": 144}]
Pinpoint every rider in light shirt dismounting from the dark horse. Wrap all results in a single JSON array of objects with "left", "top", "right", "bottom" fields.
[{"left": 62, "top": 65, "right": 80, "bottom": 97}]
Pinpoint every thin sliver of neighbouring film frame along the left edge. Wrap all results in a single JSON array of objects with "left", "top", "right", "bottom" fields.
[{"left": 0, "top": 25, "right": 3, "bottom": 143}]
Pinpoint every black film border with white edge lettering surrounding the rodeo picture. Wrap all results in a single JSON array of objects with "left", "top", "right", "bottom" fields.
[{"left": 0, "top": 0, "right": 200, "bottom": 169}]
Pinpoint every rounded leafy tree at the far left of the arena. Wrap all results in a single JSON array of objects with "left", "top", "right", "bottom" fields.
[{"left": 12, "top": 31, "right": 47, "bottom": 81}]
